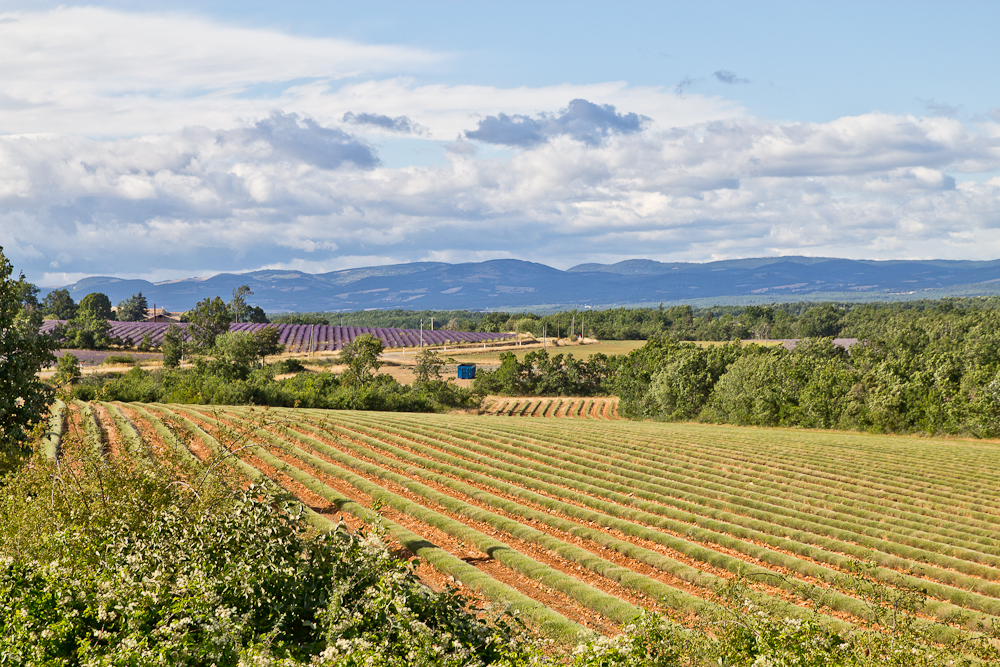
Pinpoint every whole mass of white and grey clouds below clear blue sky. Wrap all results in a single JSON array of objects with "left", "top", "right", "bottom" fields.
[{"left": 0, "top": 8, "right": 1000, "bottom": 285}]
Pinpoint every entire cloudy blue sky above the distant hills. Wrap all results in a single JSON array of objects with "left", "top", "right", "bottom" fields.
[{"left": 0, "top": 0, "right": 1000, "bottom": 287}]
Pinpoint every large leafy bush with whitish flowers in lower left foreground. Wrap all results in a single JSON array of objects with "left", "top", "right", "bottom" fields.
[{"left": 0, "top": 440, "right": 524, "bottom": 667}]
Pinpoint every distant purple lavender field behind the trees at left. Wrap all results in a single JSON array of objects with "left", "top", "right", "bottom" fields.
[{"left": 42, "top": 320, "right": 509, "bottom": 352}]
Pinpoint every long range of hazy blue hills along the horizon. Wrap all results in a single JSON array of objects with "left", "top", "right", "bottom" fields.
[{"left": 43, "top": 257, "right": 1000, "bottom": 313}]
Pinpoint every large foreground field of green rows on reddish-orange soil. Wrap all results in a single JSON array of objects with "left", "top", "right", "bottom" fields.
[{"left": 46, "top": 399, "right": 1000, "bottom": 640}]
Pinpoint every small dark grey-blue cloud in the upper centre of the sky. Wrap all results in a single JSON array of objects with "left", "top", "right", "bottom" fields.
[{"left": 465, "top": 99, "right": 649, "bottom": 148}]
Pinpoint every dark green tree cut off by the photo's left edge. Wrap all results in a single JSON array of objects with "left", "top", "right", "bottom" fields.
[{"left": 0, "top": 248, "right": 55, "bottom": 471}]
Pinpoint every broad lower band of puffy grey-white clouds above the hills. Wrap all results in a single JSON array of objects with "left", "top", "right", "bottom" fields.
[{"left": 0, "top": 106, "right": 1000, "bottom": 279}]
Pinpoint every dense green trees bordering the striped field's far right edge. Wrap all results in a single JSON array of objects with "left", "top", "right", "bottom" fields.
[{"left": 475, "top": 300, "right": 1000, "bottom": 437}]
